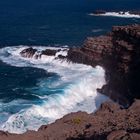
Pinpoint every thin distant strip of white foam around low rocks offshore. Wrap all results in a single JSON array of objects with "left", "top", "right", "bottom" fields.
[{"left": 89, "top": 11, "right": 140, "bottom": 18}]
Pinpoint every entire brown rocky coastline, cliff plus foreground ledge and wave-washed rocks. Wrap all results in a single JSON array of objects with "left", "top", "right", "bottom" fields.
[{"left": 0, "top": 24, "right": 140, "bottom": 140}]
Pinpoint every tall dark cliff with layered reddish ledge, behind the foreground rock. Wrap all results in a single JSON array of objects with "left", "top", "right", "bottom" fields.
[{"left": 68, "top": 25, "right": 140, "bottom": 105}]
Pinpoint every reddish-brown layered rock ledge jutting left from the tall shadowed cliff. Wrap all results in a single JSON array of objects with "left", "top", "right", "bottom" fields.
[{"left": 68, "top": 35, "right": 112, "bottom": 66}]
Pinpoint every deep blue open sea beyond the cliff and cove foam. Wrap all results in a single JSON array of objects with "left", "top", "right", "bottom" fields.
[{"left": 0, "top": 0, "right": 140, "bottom": 46}]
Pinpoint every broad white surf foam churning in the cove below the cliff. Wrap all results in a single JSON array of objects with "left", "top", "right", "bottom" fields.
[{"left": 0, "top": 46, "right": 108, "bottom": 133}]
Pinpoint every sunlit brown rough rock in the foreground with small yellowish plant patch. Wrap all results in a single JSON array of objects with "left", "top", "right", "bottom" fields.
[{"left": 0, "top": 100, "right": 140, "bottom": 140}]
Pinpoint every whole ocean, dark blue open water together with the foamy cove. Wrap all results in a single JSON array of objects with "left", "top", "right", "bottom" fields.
[{"left": 0, "top": 0, "right": 140, "bottom": 133}]
